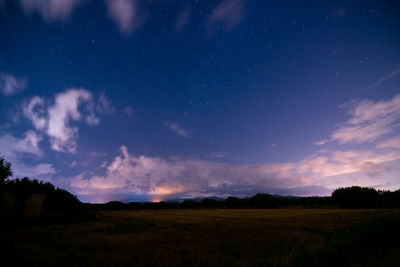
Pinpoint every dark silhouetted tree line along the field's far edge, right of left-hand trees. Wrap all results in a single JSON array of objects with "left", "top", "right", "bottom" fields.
[{"left": 96, "top": 186, "right": 400, "bottom": 210}]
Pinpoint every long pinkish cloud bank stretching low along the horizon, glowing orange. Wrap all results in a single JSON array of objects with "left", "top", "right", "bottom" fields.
[{"left": 68, "top": 146, "right": 400, "bottom": 201}]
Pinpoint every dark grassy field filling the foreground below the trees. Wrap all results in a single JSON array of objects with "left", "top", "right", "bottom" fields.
[{"left": 0, "top": 209, "right": 400, "bottom": 266}]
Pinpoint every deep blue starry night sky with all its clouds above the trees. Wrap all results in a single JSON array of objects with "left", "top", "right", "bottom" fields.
[{"left": 0, "top": 0, "right": 400, "bottom": 202}]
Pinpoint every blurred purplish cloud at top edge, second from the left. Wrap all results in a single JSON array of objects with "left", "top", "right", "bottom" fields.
[{"left": 106, "top": 0, "right": 145, "bottom": 35}]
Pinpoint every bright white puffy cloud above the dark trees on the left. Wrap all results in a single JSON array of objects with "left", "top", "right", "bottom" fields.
[{"left": 23, "top": 88, "right": 104, "bottom": 153}]
